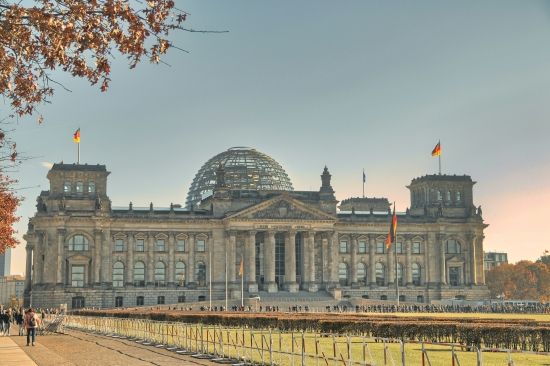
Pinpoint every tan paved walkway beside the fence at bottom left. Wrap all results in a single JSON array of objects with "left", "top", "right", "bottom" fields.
[{"left": 0, "top": 330, "right": 217, "bottom": 366}]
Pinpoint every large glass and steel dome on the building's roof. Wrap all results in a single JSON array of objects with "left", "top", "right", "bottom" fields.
[{"left": 186, "top": 147, "right": 294, "bottom": 207}]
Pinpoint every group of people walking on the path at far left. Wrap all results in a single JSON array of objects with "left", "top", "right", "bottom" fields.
[{"left": 0, "top": 308, "right": 45, "bottom": 346}]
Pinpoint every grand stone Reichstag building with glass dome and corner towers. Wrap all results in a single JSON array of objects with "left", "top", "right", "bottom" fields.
[{"left": 24, "top": 148, "right": 488, "bottom": 308}]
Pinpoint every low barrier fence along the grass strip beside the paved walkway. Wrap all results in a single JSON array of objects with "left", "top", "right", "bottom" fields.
[{"left": 64, "top": 315, "right": 550, "bottom": 366}]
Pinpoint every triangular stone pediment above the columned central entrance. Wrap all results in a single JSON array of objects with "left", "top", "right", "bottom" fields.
[{"left": 229, "top": 195, "right": 335, "bottom": 221}]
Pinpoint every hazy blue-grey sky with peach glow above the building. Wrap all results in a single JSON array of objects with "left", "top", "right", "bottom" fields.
[{"left": 4, "top": 0, "right": 550, "bottom": 273}]
